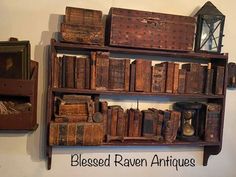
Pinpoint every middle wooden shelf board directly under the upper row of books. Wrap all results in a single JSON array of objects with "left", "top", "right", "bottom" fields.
[{"left": 52, "top": 88, "right": 224, "bottom": 99}]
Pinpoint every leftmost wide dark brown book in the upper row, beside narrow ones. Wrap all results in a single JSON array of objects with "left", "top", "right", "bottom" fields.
[{"left": 62, "top": 55, "right": 76, "bottom": 88}]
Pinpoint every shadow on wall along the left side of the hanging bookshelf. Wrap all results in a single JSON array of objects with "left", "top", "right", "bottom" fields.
[{"left": 27, "top": 14, "right": 63, "bottom": 164}]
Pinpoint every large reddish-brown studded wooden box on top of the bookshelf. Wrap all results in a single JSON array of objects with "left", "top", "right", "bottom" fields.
[{"left": 106, "top": 8, "right": 195, "bottom": 51}]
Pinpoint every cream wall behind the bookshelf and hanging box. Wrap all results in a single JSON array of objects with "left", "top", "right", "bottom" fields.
[{"left": 0, "top": 0, "right": 236, "bottom": 177}]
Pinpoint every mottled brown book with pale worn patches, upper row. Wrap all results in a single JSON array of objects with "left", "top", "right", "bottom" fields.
[{"left": 152, "top": 64, "right": 166, "bottom": 93}]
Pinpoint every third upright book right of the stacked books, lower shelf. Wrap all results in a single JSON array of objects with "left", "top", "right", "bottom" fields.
[{"left": 116, "top": 108, "right": 125, "bottom": 137}]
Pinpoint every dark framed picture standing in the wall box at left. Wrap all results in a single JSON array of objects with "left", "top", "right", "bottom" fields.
[{"left": 0, "top": 41, "right": 30, "bottom": 79}]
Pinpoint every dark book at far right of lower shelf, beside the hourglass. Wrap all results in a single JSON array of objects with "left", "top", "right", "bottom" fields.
[{"left": 205, "top": 103, "right": 221, "bottom": 142}]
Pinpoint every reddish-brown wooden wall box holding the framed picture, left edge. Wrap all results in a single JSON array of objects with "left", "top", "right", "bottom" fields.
[{"left": 0, "top": 61, "right": 38, "bottom": 130}]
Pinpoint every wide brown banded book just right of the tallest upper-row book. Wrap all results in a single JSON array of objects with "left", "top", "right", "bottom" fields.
[{"left": 109, "top": 58, "right": 130, "bottom": 91}]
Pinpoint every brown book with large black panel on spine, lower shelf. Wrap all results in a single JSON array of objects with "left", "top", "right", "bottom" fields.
[{"left": 142, "top": 110, "right": 155, "bottom": 137}]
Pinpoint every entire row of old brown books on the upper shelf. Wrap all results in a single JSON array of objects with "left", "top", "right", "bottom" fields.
[{"left": 52, "top": 52, "right": 225, "bottom": 95}]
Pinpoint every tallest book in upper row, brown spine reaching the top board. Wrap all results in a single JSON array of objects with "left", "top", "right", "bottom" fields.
[{"left": 96, "top": 52, "right": 109, "bottom": 90}]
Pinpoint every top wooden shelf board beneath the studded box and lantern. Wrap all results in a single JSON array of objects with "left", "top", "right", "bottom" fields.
[{"left": 54, "top": 42, "right": 228, "bottom": 59}]
